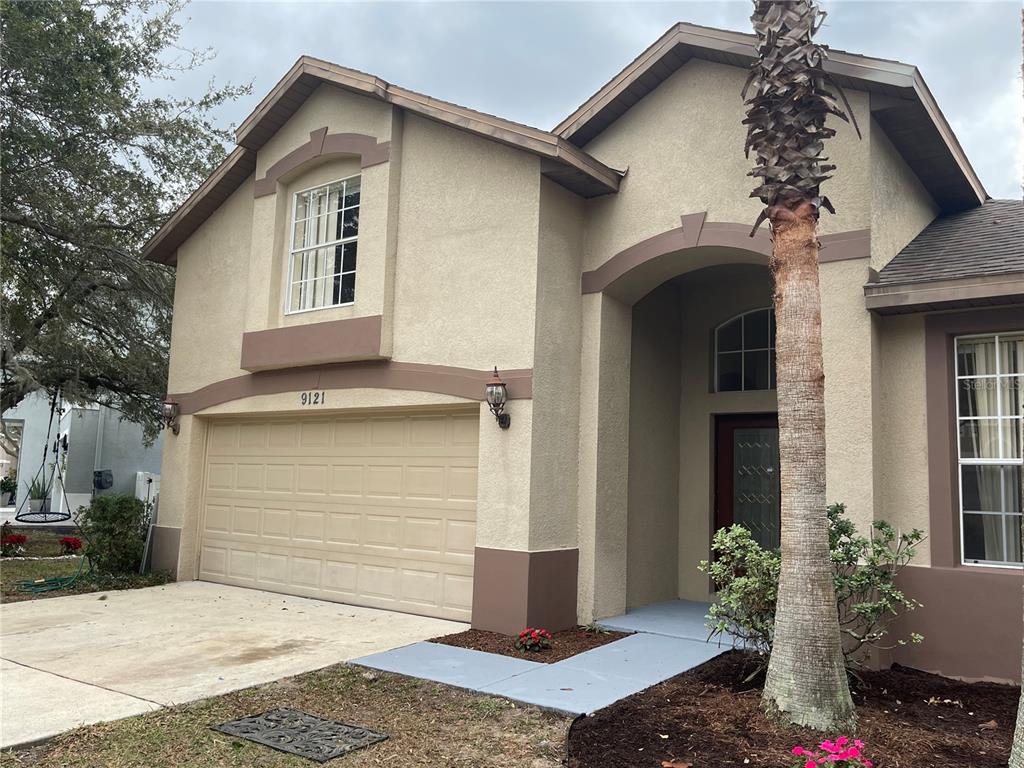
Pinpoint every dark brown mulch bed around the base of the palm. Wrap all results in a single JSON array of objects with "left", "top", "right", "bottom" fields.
[{"left": 568, "top": 651, "right": 1020, "bottom": 768}]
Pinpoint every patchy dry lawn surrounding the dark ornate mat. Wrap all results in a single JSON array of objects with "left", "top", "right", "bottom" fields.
[{"left": 0, "top": 665, "right": 572, "bottom": 768}]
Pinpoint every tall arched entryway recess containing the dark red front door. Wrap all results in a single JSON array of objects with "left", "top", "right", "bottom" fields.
[{"left": 626, "top": 263, "right": 778, "bottom": 608}]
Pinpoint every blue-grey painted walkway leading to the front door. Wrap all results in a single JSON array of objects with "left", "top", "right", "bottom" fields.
[{"left": 354, "top": 600, "right": 727, "bottom": 715}]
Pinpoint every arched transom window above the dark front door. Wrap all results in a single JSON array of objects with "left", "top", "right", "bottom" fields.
[{"left": 715, "top": 307, "right": 775, "bottom": 392}]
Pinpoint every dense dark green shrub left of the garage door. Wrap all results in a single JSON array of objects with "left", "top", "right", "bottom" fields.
[{"left": 80, "top": 494, "right": 150, "bottom": 573}]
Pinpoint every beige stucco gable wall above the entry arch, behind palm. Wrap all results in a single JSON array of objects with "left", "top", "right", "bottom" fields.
[{"left": 584, "top": 59, "right": 870, "bottom": 269}]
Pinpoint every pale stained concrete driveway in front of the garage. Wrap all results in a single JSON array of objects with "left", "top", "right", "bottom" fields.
[{"left": 0, "top": 582, "right": 466, "bottom": 748}]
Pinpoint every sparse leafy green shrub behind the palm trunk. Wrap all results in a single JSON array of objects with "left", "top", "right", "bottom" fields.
[{"left": 698, "top": 504, "right": 925, "bottom": 667}]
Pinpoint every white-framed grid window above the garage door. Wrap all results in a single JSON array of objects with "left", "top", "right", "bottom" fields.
[{"left": 288, "top": 176, "right": 359, "bottom": 312}]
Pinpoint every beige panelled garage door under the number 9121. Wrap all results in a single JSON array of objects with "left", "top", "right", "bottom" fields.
[{"left": 200, "top": 412, "right": 477, "bottom": 621}]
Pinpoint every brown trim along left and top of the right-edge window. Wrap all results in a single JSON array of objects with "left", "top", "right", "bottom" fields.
[{"left": 925, "top": 307, "right": 1024, "bottom": 569}]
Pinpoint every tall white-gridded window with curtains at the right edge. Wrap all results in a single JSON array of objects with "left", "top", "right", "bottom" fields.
[{"left": 956, "top": 333, "right": 1024, "bottom": 565}]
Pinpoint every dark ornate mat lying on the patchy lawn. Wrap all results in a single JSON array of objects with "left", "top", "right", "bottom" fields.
[{"left": 212, "top": 709, "right": 387, "bottom": 763}]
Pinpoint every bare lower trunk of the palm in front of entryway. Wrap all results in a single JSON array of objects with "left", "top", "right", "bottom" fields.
[{"left": 764, "top": 202, "right": 856, "bottom": 732}]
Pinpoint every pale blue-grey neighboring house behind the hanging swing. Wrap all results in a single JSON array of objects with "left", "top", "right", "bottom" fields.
[{"left": 3, "top": 392, "right": 164, "bottom": 520}]
